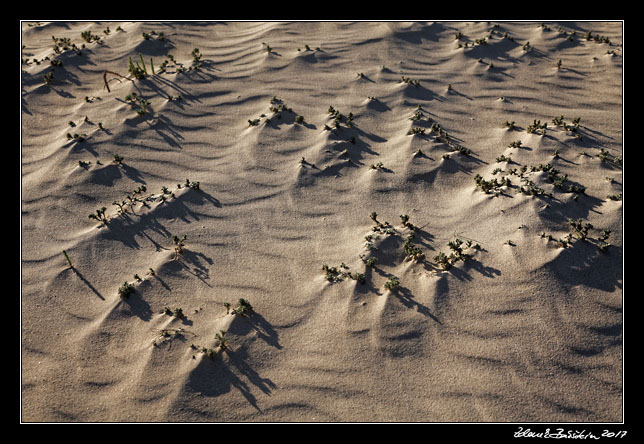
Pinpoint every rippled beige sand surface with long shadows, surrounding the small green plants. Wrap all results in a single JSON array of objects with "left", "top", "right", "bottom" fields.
[{"left": 21, "top": 22, "right": 623, "bottom": 422}]
